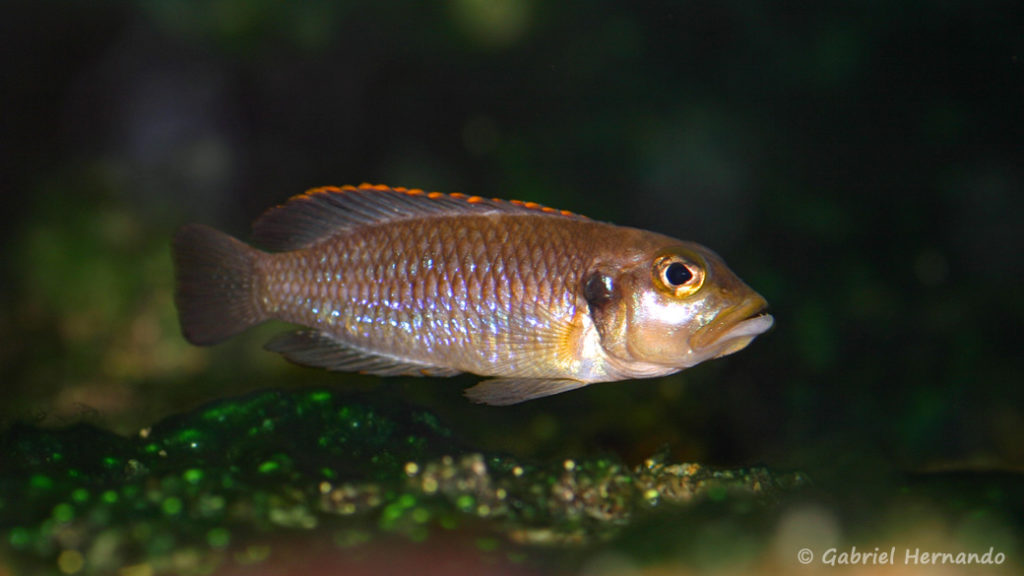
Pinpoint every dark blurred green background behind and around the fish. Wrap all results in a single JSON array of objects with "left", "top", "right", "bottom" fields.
[{"left": 0, "top": 0, "right": 1024, "bottom": 480}]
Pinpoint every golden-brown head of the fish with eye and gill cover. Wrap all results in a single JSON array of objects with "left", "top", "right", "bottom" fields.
[{"left": 585, "top": 241, "right": 774, "bottom": 377}]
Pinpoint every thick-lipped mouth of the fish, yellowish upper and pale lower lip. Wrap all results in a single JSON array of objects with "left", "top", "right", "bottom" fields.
[{"left": 690, "top": 295, "right": 775, "bottom": 358}]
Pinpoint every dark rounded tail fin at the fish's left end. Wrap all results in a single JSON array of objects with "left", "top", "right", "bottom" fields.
[{"left": 173, "top": 224, "right": 266, "bottom": 345}]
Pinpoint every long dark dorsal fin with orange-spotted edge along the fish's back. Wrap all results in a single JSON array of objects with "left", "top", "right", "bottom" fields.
[{"left": 247, "top": 183, "right": 588, "bottom": 250}]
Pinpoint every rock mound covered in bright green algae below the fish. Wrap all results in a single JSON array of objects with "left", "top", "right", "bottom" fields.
[{"left": 0, "top": 390, "right": 801, "bottom": 574}]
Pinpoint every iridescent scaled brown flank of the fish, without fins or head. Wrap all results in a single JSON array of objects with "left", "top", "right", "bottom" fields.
[{"left": 261, "top": 216, "right": 581, "bottom": 371}]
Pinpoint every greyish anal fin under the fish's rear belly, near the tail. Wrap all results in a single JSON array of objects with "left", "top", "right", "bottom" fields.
[{"left": 263, "top": 330, "right": 461, "bottom": 376}]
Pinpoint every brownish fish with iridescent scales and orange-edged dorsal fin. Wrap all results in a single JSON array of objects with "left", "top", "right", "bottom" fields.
[{"left": 172, "top": 183, "right": 774, "bottom": 406}]
